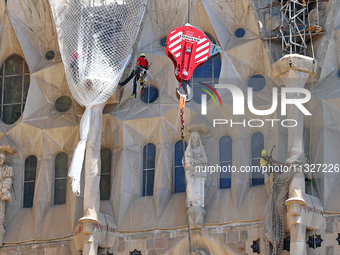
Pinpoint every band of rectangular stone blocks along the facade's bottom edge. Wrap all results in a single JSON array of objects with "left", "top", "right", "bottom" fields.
[{"left": 1, "top": 216, "right": 340, "bottom": 255}]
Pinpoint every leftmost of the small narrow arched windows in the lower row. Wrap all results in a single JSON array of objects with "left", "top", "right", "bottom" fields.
[{"left": 24, "top": 156, "right": 38, "bottom": 208}]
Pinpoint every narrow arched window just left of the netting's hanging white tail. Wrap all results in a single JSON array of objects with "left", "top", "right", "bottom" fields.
[{"left": 54, "top": 152, "right": 68, "bottom": 205}]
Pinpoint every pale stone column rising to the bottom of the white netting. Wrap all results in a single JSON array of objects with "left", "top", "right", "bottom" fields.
[{"left": 78, "top": 103, "right": 105, "bottom": 255}]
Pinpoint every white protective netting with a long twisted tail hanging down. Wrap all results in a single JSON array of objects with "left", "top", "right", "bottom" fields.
[{"left": 49, "top": 0, "right": 146, "bottom": 194}]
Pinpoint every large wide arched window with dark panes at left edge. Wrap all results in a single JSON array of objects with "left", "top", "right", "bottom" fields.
[{"left": 0, "top": 55, "right": 30, "bottom": 124}]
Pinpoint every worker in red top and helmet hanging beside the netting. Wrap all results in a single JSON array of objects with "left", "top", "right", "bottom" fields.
[{"left": 118, "top": 53, "right": 150, "bottom": 98}]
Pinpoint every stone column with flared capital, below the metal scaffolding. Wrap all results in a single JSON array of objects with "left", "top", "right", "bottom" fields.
[{"left": 273, "top": 54, "right": 315, "bottom": 255}]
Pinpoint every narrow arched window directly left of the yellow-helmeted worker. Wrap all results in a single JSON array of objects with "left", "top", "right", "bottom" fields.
[{"left": 251, "top": 132, "right": 264, "bottom": 186}]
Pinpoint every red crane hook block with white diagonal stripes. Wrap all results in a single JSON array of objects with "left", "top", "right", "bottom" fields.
[{"left": 165, "top": 24, "right": 211, "bottom": 82}]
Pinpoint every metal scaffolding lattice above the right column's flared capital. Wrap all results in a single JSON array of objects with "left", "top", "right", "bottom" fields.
[{"left": 259, "top": 0, "right": 328, "bottom": 56}]
